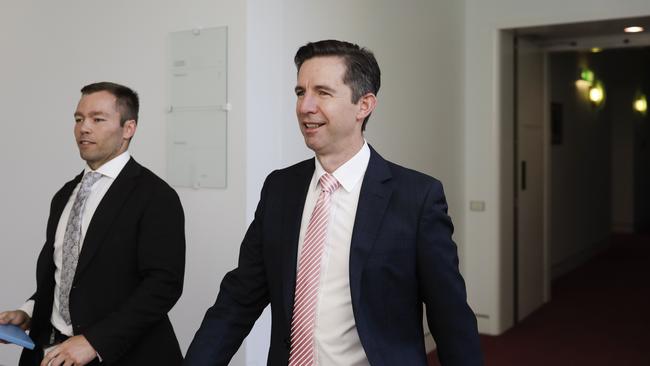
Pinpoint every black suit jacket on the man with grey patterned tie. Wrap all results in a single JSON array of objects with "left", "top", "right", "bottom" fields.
[{"left": 20, "top": 159, "right": 185, "bottom": 365}]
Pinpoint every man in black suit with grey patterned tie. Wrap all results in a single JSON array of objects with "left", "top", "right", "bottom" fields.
[{"left": 0, "top": 82, "right": 185, "bottom": 366}]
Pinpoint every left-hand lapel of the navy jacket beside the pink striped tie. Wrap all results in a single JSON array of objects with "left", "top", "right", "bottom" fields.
[{"left": 282, "top": 159, "right": 316, "bottom": 327}]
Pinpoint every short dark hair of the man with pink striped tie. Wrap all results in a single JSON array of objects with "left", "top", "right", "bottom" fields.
[{"left": 293, "top": 39, "right": 381, "bottom": 131}]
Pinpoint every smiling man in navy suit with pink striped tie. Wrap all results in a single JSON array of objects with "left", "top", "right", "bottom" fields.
[{"left": 185, "top": 40, "right": 482, "bottom": 366}]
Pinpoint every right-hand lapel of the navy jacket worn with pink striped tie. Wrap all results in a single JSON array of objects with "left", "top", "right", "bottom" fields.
[{"left": 350, "top": 147, "right": 393, "bottom": 305}]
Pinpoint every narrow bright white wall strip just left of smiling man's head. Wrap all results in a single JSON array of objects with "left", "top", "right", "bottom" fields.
[{"left": 245, "top": 0, "right": 282, "bottom": 366}]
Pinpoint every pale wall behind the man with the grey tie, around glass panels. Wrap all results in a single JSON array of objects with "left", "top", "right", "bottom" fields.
[{"left": 0, "top": 0, "right": 246, "bottom": 365}]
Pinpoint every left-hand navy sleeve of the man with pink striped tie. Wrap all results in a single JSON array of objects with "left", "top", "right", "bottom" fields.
[{"left": 185, "top": 176, "right": 270, "bottom": 366}]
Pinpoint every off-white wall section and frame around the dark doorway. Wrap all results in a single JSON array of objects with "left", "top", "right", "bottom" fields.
[{"left": 463, "top": 0, "right": 650, "bottom": 334}]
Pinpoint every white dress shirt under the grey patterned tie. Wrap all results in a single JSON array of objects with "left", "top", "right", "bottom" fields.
[{"left": 20, "top": 151, "right": 131, "bottom": 336}]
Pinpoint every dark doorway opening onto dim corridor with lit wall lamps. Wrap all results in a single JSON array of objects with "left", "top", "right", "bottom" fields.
[{"left": 501, "top": 18, "right": 650, "bottom": 324}]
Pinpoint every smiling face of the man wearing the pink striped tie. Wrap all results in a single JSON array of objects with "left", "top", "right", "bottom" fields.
[{"left": 296, "top": 56, "right": 365, "bottom": 157}]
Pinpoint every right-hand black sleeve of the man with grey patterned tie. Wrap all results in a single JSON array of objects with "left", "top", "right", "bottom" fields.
[{"left": 83, "top": 184, "right": 185, "bottom": 364}]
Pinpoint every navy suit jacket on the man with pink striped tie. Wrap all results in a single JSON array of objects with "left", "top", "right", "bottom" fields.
[{"left": 185, "top": 149, "right": 482, "bottom": 366}]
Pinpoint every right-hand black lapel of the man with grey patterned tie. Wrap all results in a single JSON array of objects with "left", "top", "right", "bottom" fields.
[{"left": 75, "top": 158, "right": 142, "bottom": 279}]
